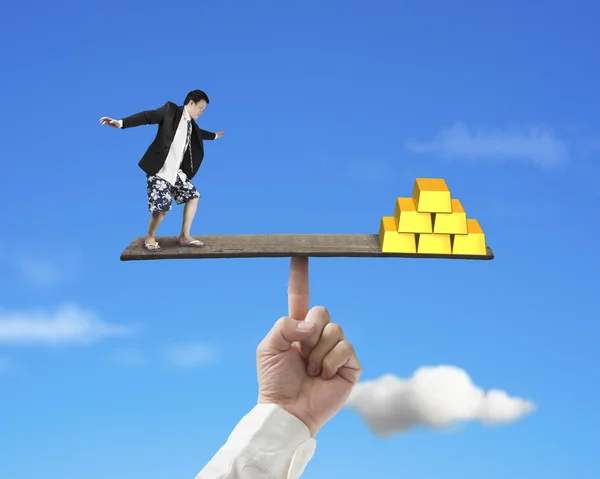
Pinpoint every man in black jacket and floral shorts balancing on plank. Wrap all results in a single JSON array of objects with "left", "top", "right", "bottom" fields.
[{"left": 100, "top": 90, "right": 225, "bottom": 251}]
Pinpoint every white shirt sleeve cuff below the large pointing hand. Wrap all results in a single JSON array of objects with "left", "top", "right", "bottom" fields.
[{"left": 195, "top": 404, "right": 316, "bottom": 479}]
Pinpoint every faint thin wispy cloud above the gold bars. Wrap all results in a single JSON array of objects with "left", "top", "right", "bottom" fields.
[{"left": 406, "top": 123, "right": 569, "bottom": 168}]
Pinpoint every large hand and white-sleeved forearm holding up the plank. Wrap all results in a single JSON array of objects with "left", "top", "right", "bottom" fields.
[{"left": 196, "top": 258, "right": 361, "bottom": 479}]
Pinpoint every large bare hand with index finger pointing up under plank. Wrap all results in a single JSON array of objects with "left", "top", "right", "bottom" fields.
[{"left": 256, "top": 258, "right": 361, "bottom": 437}]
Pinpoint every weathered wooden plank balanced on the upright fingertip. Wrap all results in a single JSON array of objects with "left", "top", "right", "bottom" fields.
[{"left": 121, "top": 234, "right": 494, "bottom": 261}]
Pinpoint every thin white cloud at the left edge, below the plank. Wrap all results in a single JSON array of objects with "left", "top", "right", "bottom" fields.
[{"left": 0, "top": 305, "right": 132, "bottom": 345}]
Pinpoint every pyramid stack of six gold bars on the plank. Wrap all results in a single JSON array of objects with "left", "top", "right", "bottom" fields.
[{"left": 379, "top": 178, "right": 487, "bottom": 256}]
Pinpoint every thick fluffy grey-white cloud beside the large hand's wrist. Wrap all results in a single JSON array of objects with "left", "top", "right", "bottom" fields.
[{"left": 346, "top": 366, "right": 535, "bottom": 436}]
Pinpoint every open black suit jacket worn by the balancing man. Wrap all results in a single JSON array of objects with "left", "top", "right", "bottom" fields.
[{"left": 123, "top": 101, "right": 217, "bottom": 179}]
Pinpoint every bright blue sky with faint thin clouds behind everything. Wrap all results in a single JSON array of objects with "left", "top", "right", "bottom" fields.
[{"left": 0, "top": 0, "right": 600, "bottom": 479}]
